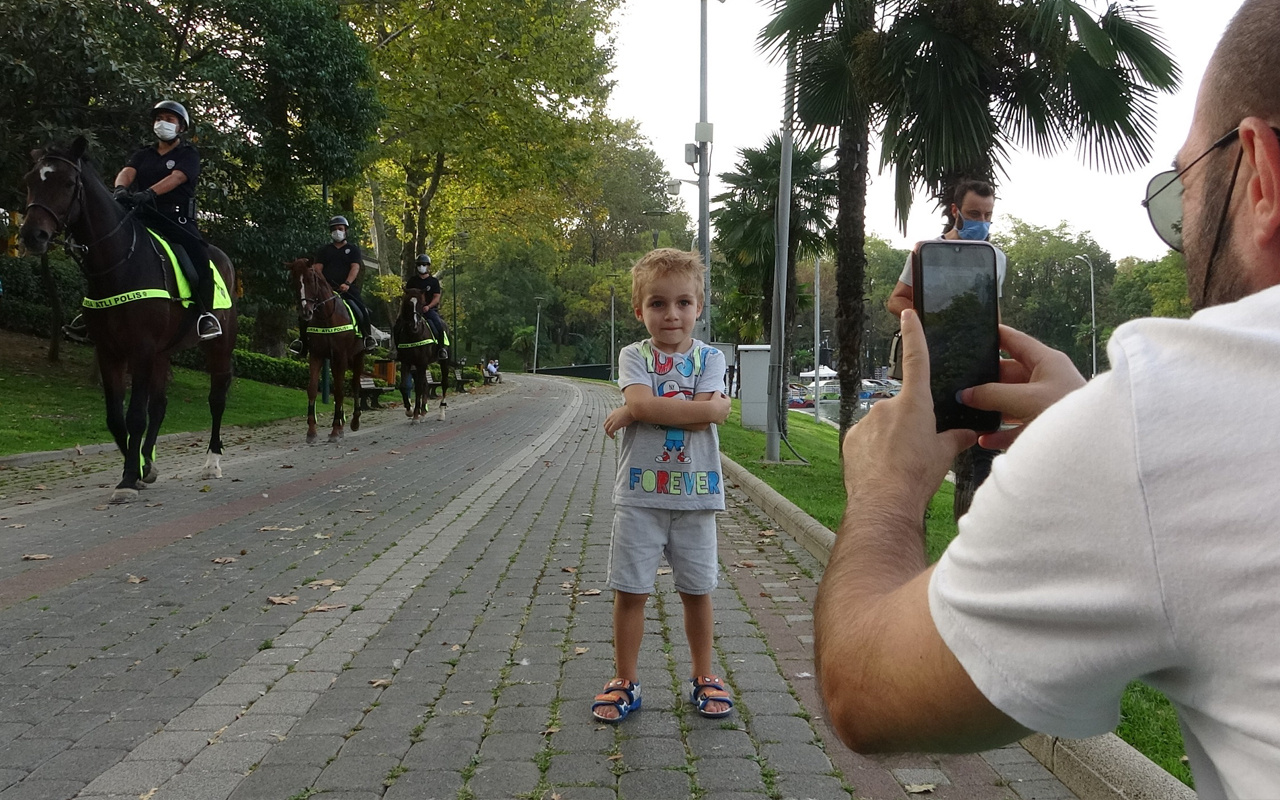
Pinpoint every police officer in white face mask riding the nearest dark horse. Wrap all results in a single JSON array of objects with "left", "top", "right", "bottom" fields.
[{"left": 65, "top": 100, "right": 223, "bottom": 340}]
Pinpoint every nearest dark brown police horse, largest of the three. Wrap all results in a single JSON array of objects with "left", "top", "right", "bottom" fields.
[{"left": 20, "top": 137, "right": 237, "bottom": 503}]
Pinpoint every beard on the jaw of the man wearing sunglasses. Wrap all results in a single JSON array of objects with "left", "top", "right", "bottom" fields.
[{"left": 1184, "top": 151, "right": 1249, "bottom": 311}]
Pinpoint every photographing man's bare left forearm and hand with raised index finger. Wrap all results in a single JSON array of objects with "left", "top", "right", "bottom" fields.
[{"left": 814, "top": 312, "right": 1025, "bottom": 751}]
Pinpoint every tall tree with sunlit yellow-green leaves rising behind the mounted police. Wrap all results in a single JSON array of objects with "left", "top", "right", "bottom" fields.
[{"left": 344, "top": 0, "right": 617, "bottom": 274}]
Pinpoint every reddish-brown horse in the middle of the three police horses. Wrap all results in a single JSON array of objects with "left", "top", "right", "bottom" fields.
[{"left": 284, "top": 259, "right": 365, "bottom": 444}]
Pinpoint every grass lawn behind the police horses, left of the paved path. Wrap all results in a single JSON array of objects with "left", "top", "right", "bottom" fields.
[{"left": 0, "top": 332, "right": 307, "bottom": 456}]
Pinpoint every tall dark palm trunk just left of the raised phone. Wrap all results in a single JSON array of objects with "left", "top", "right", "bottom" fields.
[{"left": 834, "top": 104, "right": 868, "bottom": 442}]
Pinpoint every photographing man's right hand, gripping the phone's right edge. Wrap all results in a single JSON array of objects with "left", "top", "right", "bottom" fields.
[{"left": 960, "top": 325, "right": 1085, "bottom": 451}]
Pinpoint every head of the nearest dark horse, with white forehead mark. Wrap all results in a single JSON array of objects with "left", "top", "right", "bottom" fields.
[{"left": 18, "top": 136, "right": 88, "bottom": 255}]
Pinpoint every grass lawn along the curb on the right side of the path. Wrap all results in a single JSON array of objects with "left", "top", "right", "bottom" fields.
[{"left": 719, "top": 401, "right": 1193, "bottom": 786}]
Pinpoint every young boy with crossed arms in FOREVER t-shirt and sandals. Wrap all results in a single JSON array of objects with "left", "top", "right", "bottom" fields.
[{"left": 591, "top": 247, "right": 733, "bottom": 722}]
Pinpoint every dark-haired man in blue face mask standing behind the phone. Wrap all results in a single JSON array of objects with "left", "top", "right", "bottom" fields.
[{"left": 886, "top": 180, "right": 1009, "bottom": 520}]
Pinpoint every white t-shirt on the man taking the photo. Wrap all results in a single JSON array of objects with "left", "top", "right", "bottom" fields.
[{"left": 929, "top": 287, "right": 1280, "bottom": 799}]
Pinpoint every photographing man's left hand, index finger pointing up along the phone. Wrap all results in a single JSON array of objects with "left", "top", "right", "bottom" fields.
[{"left": 844, "top": 310, "right": 978, "bottom": 514}]
